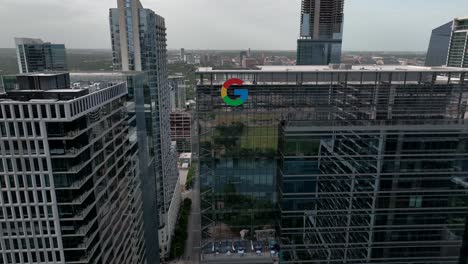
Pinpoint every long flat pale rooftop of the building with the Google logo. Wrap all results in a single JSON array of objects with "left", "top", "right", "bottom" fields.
[{"left": 197, "top": 65, "right": 468, "bottom": 73}]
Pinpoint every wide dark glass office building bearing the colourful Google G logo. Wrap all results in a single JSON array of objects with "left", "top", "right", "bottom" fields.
[{"left": 197, "top": 66, "right": 468, "bottom": 264}]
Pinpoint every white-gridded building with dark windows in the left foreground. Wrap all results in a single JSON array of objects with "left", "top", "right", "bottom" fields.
[{"left": 0, "top": 73, "right": 146, "bottom": 264}]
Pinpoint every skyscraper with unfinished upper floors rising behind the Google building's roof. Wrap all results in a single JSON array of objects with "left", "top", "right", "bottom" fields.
[{"left": 297, "top": 0, "right": 344, "bottom": 65}]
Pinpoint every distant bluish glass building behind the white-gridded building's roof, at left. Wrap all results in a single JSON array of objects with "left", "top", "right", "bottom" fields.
[{"left": 15, "top": 38, "right": 67, "bottom": 73}]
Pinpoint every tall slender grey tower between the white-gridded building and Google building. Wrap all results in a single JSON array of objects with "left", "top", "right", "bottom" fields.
[{"left": 110, "top": 0, "right": 180, "bottom": 263}]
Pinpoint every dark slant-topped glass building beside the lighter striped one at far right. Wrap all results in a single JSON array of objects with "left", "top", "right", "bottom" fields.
[{"left": 425, "top": 21, "right": 453, "bottom": 66}]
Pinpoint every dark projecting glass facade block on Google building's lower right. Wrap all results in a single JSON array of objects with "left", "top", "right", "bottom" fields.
[{"left": 279, "top": 125, "right": 468, "bottom": 263}]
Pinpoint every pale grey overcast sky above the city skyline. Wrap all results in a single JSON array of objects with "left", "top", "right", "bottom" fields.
[{"left": 0, "top": 0, "right": 468, "bottom": 51}]
